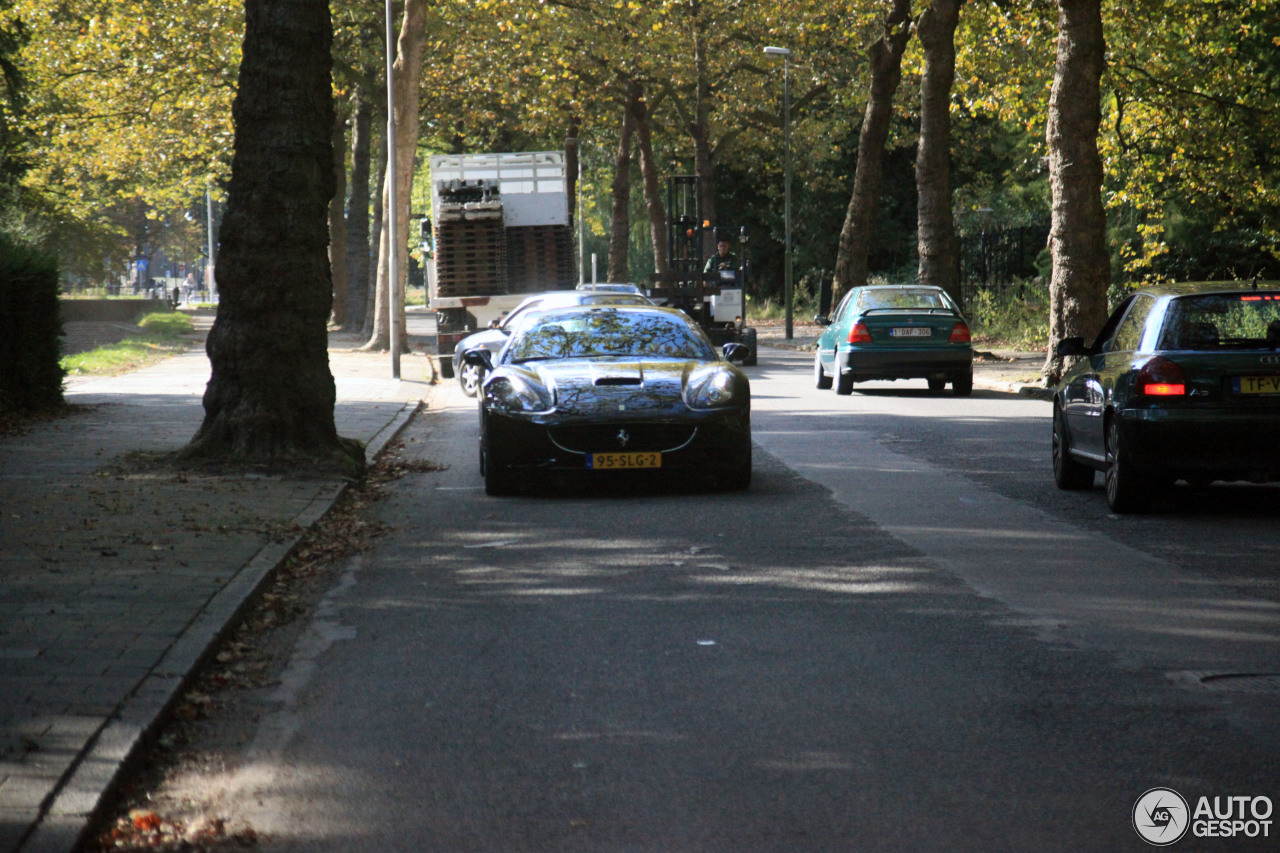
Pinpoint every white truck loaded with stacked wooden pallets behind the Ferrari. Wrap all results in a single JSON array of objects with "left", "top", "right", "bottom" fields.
[{"left": 424, "top": 151, "right": 576, "bottom": 378}]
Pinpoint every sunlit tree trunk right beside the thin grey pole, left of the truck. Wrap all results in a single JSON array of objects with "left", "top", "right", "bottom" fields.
[{"left": 364, "top": 0, "right": 428, "bottom": 350}]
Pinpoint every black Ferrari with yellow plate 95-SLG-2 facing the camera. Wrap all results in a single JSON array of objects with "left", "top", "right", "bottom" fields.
[{"left": 463, "top": 305, "right": 751, "bottom": 494}]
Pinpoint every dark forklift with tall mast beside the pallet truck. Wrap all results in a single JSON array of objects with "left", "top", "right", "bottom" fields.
[{"left": 649, "top": 175, "right": 756, "bottom": 365}]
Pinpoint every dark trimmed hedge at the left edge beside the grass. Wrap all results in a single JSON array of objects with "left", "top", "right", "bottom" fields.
[{"left": 0, "top": 234, "right": 65, "bottom": 414}]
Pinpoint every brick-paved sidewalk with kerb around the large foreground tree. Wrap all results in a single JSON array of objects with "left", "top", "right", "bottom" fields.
[{"left": 0, "top": 333, "right": 430, "bottom": 853}]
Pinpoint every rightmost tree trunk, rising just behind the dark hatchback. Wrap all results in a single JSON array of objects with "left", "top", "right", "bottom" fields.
[{"left": 1044, "top": 0, "right": 1111, "bottom": 383}]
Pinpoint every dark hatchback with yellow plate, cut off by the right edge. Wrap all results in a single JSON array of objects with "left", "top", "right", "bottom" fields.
[{"left": 1052, "top": 282, "right": 1280, "bottom": 512}]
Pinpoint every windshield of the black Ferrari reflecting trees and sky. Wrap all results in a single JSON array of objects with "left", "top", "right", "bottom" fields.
[{"left": 509, "top": 307, "right": 716, "bottom": 364}]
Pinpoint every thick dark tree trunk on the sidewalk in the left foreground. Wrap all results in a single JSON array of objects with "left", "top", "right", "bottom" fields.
[{"left": 183, "top": 0, "right": 364, "bottom": 471}]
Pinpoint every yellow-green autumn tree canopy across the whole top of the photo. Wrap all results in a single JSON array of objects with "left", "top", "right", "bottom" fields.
[{"left": 0, "top": 0, "right": 1280, "bottom": 425}]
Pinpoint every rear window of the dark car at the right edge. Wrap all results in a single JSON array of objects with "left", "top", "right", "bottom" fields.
[{"left": 1157, "top": 292, "right": 1280, "bottom": 350}]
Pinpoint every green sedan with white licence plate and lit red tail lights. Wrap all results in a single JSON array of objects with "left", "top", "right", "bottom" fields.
[{"left": 813, "top": 284, "right": 973, "bottom": 397}]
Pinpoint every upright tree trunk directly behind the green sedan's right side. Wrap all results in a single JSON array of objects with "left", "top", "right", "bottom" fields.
[{"left": 915, "top": 0, "right": 964, "bottom": 304}]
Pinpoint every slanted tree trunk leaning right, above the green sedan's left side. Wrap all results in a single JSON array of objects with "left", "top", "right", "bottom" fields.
[{"left": 831, "top": 0, "right": 911, "bottom": 305}]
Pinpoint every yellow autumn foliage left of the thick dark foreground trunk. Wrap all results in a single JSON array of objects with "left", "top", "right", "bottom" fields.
[{"left": 4, "top": 0, "right": 243, "bottom": 218}]
